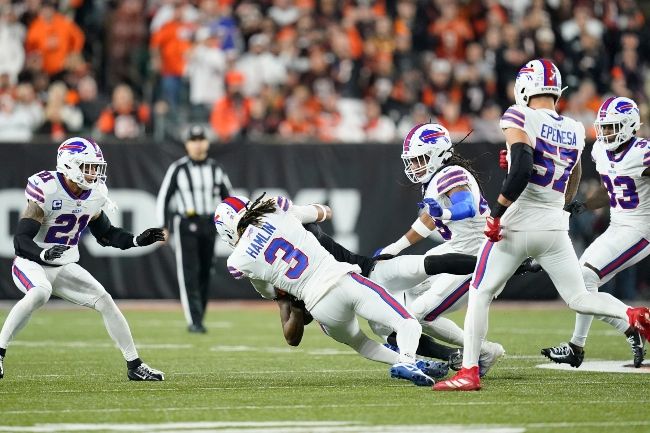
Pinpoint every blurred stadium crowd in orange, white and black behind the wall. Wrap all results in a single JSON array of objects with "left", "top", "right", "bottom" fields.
[{"left": 0, "top": 0, "right": 650, "bottom": 143}]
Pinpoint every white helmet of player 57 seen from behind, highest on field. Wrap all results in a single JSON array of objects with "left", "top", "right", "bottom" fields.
[{"left": 515, "top": 59, "right": 564, "bottom": 107}]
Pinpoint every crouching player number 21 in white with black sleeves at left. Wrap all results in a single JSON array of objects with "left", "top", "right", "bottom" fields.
[{"left": 0, "top": 137, "right": 164, "bottom": 380}]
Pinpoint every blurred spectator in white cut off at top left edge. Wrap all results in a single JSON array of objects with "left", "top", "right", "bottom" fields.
[{"left": 0, "top": 5, "right": 25, "bottom": 83}]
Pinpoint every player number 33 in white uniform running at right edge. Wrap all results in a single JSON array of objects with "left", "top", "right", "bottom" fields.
[{"left": 542, "top": 97, "right": 650, "bottom": 368}]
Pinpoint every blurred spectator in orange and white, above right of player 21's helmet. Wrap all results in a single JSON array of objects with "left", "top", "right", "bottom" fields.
[{"left": 97, "top": 84, "right": 151, "bottom": 139}]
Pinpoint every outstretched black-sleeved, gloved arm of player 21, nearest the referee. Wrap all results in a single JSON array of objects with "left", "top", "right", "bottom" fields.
[{"left": 88, "top": 211, "right": 165, "bottom": 250}]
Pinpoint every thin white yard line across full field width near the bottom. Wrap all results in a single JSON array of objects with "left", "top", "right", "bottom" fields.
[{"left": 2, "top": 398, "right": 650, "bottom": 416}]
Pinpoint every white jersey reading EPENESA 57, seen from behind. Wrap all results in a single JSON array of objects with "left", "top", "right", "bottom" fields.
[{"left": 499, "top": 105, "right": 585, "bottom": 231}]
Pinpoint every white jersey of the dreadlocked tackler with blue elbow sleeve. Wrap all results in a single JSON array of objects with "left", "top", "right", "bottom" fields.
[{"left": 422, "top": 165, "right": 490, "bottom": 255}]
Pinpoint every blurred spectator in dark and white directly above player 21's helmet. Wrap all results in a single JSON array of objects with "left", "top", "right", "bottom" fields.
[{"left": 38, "top": 81, "right": 83, "bottom": 142}]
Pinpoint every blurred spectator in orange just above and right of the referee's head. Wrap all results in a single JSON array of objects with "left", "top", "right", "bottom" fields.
[{"left": 210, "top": 70, "right": 252, "bottom": 142}]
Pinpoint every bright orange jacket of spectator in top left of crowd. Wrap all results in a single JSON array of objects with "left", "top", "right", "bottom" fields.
[{"left": 25, "top": 13, "right": 86, "bottom": 75}]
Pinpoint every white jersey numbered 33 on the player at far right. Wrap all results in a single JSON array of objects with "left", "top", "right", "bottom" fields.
[{"left": 591, "top": 137, "right": 650, "bottom": 233}]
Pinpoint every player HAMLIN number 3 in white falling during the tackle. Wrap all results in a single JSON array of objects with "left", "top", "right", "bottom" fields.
[{"left": 214, "top": 197, "right": 433, "bottom": 385}]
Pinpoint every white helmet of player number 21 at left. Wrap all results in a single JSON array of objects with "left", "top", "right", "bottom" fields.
[{"left": 56, "top": 137, "right": 106, "bottom": 190}]
